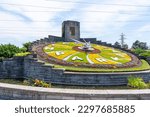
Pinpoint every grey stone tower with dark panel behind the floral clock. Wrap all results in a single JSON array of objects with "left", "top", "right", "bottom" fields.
[{"left": 62, "top": 20, "right": 80, "bottom": 41}]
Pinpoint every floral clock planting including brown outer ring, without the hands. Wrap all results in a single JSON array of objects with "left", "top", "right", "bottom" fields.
[{"left": 33, "top": 42, "right": 141, "bottom": 68}]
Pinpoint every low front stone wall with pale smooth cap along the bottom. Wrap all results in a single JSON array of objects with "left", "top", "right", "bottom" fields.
[{"left": 0, "top": 83, "right": 150, "bottom": 100}]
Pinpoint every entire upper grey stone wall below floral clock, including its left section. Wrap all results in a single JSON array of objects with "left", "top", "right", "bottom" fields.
[{"left": 0, "top": 55, "right": 150, "bottom": 86}]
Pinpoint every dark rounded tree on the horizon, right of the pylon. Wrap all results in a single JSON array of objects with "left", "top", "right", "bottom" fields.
[{"left": 132, "top": 40, "right": 148, "bottom": 50}]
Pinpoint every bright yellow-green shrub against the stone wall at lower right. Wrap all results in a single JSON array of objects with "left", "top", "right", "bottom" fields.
[{"left": 128, "top": 76, "right": 148, "bottom": 89}]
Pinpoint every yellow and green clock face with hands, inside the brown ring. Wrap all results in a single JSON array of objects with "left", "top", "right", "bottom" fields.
[{"left": 43, "top": 42, "right": 132, "bottom": 65}]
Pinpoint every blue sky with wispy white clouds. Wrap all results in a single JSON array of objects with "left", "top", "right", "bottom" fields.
[{"left": 0, "top": 0, "right": 150, "bottom": 46}]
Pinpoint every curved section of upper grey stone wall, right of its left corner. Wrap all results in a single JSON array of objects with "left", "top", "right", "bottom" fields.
[{"left": 24, "top": 54, "right": 150, "bottom": 86}]
